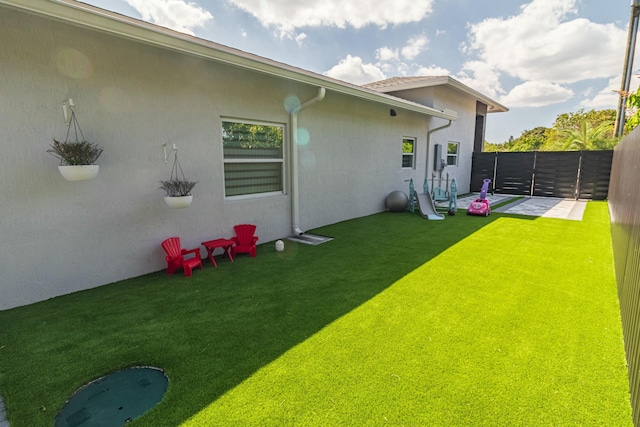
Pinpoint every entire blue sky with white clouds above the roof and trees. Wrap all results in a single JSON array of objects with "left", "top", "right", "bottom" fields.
[{"left": 86, "top": 0, "right": 640, "bottom": 143}]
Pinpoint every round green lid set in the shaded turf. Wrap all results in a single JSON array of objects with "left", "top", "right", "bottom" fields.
[{"left": 55, "top": 367, "right": 169, "bottom": 427}]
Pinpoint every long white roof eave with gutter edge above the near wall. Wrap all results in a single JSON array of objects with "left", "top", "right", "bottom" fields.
[{"left": 0, "top": 0, "right": 457, "bottom": 120}]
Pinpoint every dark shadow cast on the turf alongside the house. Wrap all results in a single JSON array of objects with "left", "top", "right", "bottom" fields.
[{"left": 0, "top": 211, "right": 497, "bottom": 427}]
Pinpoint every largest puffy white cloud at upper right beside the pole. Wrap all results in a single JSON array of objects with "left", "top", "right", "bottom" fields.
[{"left": 466, "top": 0, "right": 626, "bottom": 83}]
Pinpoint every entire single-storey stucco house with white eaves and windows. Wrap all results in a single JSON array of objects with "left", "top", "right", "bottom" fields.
[{"left": 0, "top": 0, "right": 506, "bottom": 310}]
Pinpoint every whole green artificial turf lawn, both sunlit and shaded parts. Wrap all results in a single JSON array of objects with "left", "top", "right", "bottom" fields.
[{"left": 0, "top": 202, "right": 633, "bottom": 427}]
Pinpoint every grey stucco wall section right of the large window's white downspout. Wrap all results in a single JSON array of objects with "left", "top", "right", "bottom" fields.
[{"left": 299, "top": 96, "right": 431, "bottom": 230}]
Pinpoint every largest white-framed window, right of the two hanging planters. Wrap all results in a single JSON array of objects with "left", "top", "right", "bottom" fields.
[{"left": 222, "top": 119, "right": 284, "bottom": 197}]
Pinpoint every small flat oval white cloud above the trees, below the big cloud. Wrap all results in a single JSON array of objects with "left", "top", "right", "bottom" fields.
[{"left": 500, "top": 81, "right": 573, "bottom": 107}]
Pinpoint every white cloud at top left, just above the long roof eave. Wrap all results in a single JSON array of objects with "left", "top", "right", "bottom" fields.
[{"left": 125, "top": 0, "right": 213, "bottom": 35}]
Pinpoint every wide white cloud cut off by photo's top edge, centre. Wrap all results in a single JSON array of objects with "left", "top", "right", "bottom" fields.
[{"left": 230, "top": 0, "right": 435, "bottom": 32}]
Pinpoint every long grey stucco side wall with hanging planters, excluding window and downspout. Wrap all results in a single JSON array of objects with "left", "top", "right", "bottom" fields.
[{"left": 0, "top": 6, "right": 440, "bottom": 310}]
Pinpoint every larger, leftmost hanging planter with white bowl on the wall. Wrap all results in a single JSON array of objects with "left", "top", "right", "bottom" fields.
[{"left": 47, "top": 102, "right": 102, "bottom": 181}]
